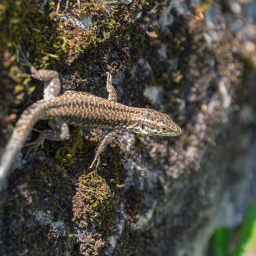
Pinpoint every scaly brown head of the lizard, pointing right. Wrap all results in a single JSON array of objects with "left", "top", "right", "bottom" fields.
[{"left": 128, "top": 109, "right": 181, "bottom": 136}]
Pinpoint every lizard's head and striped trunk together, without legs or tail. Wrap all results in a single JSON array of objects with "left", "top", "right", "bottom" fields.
[{"left": 41, "top": 91, "right": 180, "bottom": 136}]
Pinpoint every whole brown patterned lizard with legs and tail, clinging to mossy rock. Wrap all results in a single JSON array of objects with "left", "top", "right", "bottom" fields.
[{"left": 0, "top": 49, "right": 181, "bottom": 192}]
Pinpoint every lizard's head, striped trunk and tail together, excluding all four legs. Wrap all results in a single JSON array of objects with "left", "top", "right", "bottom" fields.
[{"left": 0, "top": 88, "right": 181, "bottom": 190}]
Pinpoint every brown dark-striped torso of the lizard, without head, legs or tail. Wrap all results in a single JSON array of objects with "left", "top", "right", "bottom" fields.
[{"left": 42, "top": 91, "right": 146, "bottom": 130}]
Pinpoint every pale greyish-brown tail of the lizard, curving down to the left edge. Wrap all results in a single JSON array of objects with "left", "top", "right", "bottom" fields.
[{"left": 0, "top": 100, "right": 50, "bottom": 192}]
